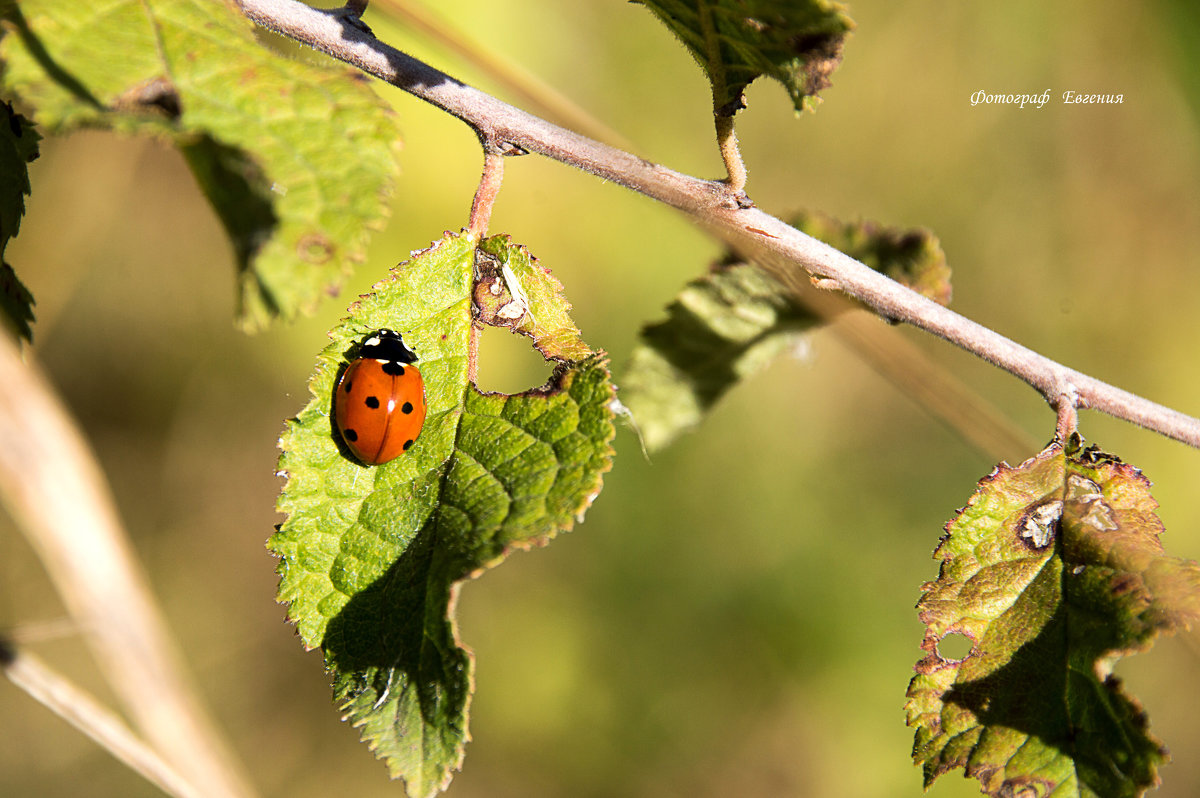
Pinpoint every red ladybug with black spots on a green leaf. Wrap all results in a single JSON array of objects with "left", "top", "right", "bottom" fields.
[{"left": 334, "top": 330, "right": 425, "bottom": 466}]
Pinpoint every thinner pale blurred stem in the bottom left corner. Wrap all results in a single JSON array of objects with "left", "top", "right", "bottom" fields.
[{"left": 0, "top": 640, "right": 204, "bottom": 798}]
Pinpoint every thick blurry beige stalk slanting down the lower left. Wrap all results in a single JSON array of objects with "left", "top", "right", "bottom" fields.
[{"left": 0, "top": 335, "right": 253, "bottom": 798}]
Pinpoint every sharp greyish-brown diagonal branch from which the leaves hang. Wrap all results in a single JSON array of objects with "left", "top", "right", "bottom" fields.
[{"left": 238, "top": 0, "right": 1200, "bottom": 448}]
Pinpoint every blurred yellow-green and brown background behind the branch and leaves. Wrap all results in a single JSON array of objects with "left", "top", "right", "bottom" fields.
[{"left": 0, "top": 0, "right": 1200, "bottom": 798}]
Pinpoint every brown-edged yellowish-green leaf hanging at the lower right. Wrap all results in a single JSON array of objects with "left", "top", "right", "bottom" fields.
[{"left": 907, "top": 438, "right": 1200, "bottom": 798}]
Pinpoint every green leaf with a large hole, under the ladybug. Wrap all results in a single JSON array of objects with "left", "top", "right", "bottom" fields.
[{"left": 269, "top": 230, "right": 613, "bottom": 797}]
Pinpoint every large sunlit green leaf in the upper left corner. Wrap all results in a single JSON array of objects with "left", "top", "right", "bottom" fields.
[{"left": 0, "top": 0, "right": 400, "bottom": 329}]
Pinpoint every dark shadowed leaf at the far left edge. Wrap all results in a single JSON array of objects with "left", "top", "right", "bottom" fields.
[{"left": 0, "top": 102, "right": 42, "bottom": 341}]
